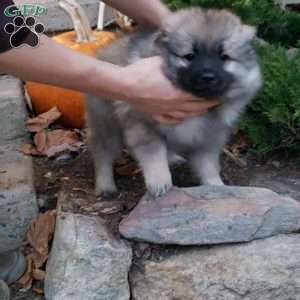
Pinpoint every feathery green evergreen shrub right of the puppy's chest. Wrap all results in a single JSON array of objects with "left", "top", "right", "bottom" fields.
[{"left": 241, "top": 46, "right": 300, "bottom": 154}]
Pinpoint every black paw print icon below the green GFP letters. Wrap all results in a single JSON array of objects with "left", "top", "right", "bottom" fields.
[{"left": 4, "top": 16, "right": 45, "bottom": 48}]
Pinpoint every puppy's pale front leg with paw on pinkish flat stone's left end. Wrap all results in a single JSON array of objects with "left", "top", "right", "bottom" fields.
[{"left": 125, "top": 124, "right": 172, "bottom": 198}]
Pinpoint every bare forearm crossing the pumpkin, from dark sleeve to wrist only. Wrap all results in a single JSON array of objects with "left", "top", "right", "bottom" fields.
[{"left": 0, "top": 36, "right": 126, "bottom": 97}]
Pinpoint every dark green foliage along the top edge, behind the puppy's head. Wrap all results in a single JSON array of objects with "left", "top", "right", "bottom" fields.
[{"left": 165, "top": 0, "right": 300, "bottom": 46}]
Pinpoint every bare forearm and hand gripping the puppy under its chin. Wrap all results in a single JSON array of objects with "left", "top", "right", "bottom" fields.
[{"left": 0, "top": 32, "right": 216, "bottom": 123}]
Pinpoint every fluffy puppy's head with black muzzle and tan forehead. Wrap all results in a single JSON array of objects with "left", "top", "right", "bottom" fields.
[{"left": 158, "top": 8, "right": 257, "bottom": 98}]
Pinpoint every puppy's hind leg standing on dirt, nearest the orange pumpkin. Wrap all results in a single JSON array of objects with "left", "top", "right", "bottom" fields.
[{"left": 87, "top": 97, "right": 122, "bottom": 198}]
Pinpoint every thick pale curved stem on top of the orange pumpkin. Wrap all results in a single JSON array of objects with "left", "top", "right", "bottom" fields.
[{"left": 59, "top": 0, "right": 95, "bottom": 43}]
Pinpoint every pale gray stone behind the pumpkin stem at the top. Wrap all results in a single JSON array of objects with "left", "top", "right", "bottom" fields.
[{"left": 30, "top": 0, "right": 114, "bottom": 32}]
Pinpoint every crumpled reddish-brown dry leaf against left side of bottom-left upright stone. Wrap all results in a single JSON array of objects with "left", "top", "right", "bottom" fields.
[{"left": 19, "top": 210, "right": 56, "bottom": 290}]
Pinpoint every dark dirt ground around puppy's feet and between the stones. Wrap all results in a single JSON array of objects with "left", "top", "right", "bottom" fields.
[{"left": 12, "top": 144, "right": 300, "bottom": 300}]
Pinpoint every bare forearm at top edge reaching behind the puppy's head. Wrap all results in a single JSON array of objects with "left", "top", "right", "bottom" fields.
[{"left": 104, "top": 0, "right": 169, "bottom": 27}]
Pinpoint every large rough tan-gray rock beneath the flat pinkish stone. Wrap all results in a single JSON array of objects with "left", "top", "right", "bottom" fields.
[{"left": 130, "top": 234, "right": 300, "bottom": 300}]
